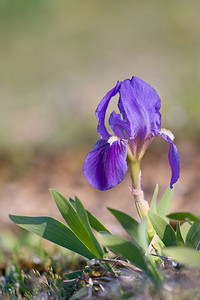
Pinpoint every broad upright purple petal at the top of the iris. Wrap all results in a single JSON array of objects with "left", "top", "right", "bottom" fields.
[{"left": 118, "top": 77, "right": 161, "bottom": 139}]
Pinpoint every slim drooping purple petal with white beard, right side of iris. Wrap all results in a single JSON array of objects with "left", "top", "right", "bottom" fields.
[{"left": 158, "top": 132, "right": 180, "bottom": 189}]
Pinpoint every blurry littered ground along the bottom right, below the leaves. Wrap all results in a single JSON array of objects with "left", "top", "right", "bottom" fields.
[{"left": 64, "top": 260, "right": 200, "bottom": 300}]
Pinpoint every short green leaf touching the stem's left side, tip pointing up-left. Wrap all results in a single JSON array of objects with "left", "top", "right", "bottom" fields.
[{"left": 108, "top": 207, "right": 140, "bottom": 243}]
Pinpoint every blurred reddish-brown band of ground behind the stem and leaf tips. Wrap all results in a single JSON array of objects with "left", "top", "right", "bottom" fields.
[{"left": 0, "top": 142, "right": 200, "bottom": 234}]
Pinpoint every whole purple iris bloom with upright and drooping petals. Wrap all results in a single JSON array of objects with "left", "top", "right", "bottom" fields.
[{"left": 83, "top": 77, "right": 180, "bottom": 191}]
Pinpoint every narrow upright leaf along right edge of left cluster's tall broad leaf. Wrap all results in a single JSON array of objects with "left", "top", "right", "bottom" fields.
[{"left": 75, "top": 197, "right": 104, "bottom": 257}]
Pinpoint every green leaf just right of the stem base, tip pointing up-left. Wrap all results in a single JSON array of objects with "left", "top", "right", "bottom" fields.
[{"left": 148, "top": 209, "right": 176, "bottom": 247}]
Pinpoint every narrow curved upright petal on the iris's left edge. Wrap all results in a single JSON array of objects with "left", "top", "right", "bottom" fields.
[{"left": 95, "top": 81, "right": 121, "bottom": 140}]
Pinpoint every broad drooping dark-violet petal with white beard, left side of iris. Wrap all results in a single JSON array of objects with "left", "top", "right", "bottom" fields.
[{"left": 83, "top": 137, "right": 128, "bottom": 191}]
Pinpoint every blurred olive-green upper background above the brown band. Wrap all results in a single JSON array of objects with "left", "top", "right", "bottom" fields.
[{"left": 0, "top": 0, "right": 200, "bottom": 154}]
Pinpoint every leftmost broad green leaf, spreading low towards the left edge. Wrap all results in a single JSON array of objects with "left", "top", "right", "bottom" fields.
[{"left": 9, "top": 215, "right": 95, "bottom": 259}]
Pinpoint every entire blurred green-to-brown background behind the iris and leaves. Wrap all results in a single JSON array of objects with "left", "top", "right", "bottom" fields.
[{"left": 0, "top": 0, "right": 200, "bottom": 230}]
